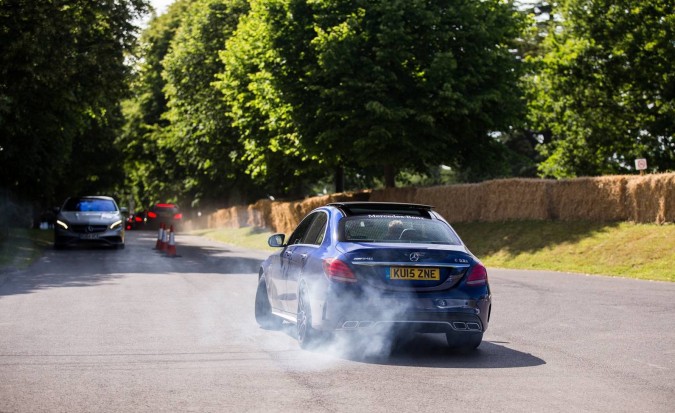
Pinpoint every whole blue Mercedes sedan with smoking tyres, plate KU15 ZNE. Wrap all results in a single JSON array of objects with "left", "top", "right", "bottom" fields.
[{"left": 255, "top": 202, "right": 491, "bottom": 350}]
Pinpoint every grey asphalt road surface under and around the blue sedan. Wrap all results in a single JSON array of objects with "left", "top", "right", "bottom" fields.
[{"left": 0, "top": 232, "right": 675, "bottom": 412}]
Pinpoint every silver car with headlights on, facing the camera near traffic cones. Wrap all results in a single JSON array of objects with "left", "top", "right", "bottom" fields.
[{"left": 54, "top": 196, "right": 126, "bottom": 249}]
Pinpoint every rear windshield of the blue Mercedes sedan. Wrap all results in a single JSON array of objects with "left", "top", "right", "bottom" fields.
[{"left": 340, "top": 215, "right": 461, "bottom": 245}]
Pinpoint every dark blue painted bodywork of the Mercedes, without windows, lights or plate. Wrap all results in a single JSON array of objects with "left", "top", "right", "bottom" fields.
[{"left": 260, "top": 205, "right": 491, "bottom": 348}]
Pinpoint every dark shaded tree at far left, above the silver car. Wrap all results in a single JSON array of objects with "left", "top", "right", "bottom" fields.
[{"left": 0, "top": 0, "right": 148, "bottom": 205}]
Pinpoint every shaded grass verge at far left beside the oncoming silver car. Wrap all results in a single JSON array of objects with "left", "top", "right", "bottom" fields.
[{"left": 0, "top": 228, "right": 54, "bottom": 271}]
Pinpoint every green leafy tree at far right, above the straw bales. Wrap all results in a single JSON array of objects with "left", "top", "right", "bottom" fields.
[{"left": 530, "top": 0, "right": 675, "bottom": 178}]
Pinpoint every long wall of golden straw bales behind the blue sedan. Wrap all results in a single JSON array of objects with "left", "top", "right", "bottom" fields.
[{"left": 195, "top": 173, "right": 675, "bottom": 229}]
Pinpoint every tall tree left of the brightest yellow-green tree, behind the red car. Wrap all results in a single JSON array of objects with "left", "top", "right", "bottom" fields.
[{"left": 163, "top": 0, "right": 256, "bottom": 204}]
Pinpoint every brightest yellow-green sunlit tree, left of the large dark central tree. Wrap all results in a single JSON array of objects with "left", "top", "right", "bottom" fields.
[{"left": 215, "top": 0, "right": 321, "bottom": 197}]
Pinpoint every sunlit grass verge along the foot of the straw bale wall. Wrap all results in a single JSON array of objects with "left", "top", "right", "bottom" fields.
[{"left": 193, "top": 221, "right": 675, "bottom": 282}]
